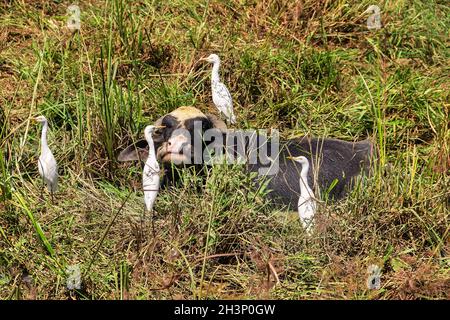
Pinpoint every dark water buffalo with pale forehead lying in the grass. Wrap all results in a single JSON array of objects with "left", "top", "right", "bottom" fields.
[{"left": 118, "top": 107, "right": 375, "bottom": 208}]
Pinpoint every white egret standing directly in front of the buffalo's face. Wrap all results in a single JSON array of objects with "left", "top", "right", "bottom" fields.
[{"left": 142, "top": 126, "right": 160, "bottom": 212}]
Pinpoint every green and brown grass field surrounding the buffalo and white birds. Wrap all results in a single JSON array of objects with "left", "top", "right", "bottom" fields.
[{"left": 0, "top": 0, "right": 450, "bottom": 299}]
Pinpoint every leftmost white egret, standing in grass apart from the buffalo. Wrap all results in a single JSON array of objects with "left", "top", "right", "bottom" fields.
[{"left": 34, "top": 116, "right": 58, "bottom": 202}]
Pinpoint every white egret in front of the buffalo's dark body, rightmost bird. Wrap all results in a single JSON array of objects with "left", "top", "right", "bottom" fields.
[{"left": 288, "top": 156, "right": 316, "bottom": 232}]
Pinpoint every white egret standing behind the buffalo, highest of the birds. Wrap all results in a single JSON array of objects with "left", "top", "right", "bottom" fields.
[{"left": 201, "top": 53, "right": 236, "bottom": 124}]
